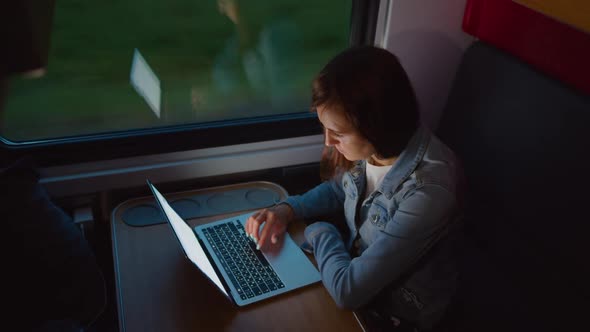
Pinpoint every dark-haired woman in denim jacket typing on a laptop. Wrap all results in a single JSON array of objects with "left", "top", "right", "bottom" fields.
[{"left": 246, "top": 46, "right": 459, "bottom": 329}]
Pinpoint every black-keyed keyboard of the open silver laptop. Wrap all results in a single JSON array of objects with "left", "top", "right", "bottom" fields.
[{"left": 203, "top": 220, "right": 285, "bottom": 300}]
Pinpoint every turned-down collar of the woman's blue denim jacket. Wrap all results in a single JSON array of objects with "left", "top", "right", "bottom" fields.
[{"left": 350, "top": 126, "right": 431, "bottom": 199}]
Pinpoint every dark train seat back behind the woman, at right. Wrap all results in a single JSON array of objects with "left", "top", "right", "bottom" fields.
[{"left": 436, "top": 41, "right": 590, "bottom": 332}]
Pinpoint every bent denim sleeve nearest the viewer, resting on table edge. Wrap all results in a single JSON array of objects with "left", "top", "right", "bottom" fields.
[{"left": 305, "top": 185, "right": 455, "bottom": 309}]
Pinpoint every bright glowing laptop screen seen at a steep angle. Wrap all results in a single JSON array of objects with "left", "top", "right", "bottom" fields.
[{"left": 148, "top": 180, "right": 229, "bottom": 296}]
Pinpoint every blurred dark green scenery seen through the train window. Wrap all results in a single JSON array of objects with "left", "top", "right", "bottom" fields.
[{"left": 0, "top": 0, "right": 351, "bottom": 142}]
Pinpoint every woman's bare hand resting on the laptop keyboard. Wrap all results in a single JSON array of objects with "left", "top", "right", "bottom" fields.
[{"left": 245, "top": 204, "right": 293, "bottom": 250}]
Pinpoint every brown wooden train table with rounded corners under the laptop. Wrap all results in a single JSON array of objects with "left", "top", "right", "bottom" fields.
[{"left": 111, "top": 183, "right": 362, "bottom": 332}]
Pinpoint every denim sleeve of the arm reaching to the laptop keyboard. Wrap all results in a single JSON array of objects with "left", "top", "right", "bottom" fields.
[{"left": 282, "top": 177, "right": 344, "bottom": 219}]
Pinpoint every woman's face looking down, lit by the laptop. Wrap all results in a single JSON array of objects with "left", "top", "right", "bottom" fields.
[{"left": 317, "top": 105, "right": 375, "bottom": 161}]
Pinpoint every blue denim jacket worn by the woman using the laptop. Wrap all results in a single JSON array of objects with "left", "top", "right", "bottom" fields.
[{"left": 285, "top": 127, "right": 460, "bottom": 329}]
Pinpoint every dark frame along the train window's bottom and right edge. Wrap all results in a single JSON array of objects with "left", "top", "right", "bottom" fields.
[{"left": 0, "top": 0, "right": 380, "bottom": 167}]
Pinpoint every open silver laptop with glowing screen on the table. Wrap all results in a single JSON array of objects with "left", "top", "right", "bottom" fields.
[{"left": 147, "top": 180, "right": 321, "bottom": 306}]
